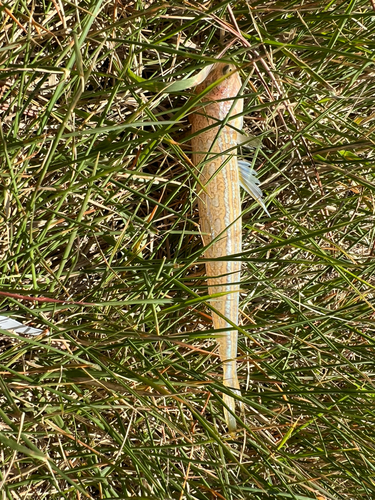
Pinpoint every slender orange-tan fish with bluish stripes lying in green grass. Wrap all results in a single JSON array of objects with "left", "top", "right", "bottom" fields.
[{"left": 189, "top": 62, "right": 269, "bottom": 434}]
